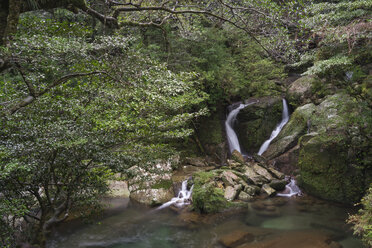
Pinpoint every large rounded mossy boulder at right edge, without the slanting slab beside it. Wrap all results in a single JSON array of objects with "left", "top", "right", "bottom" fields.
[{"left": 298, "top": 94, "right": 372, "bottom": 204}]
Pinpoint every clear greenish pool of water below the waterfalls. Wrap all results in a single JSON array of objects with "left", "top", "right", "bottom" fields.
[{"left": 47, "top": 197, "right": 363, "bottom": 248}]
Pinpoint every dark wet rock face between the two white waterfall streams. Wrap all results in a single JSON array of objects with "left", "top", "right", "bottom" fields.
[{"left": 235, "top": 97, "right": 282, "bottom": 153}]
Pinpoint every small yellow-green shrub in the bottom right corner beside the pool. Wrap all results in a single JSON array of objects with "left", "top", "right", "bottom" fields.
[{"left": 348, "top": 187, "right": 372, "bottom": 246}]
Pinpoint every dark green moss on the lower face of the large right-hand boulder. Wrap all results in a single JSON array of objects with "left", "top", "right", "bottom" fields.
[{"left": 299, "top": 135, "right": 364, "bottom": 204}]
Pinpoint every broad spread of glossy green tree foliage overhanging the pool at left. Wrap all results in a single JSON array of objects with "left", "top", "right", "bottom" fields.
[{"left": 0, "top": 12, "right": 208, "bottom": 245}]
